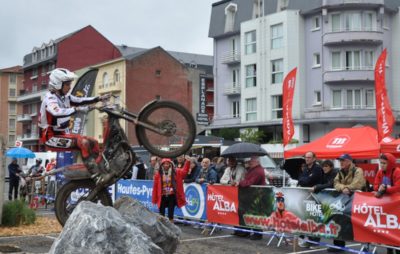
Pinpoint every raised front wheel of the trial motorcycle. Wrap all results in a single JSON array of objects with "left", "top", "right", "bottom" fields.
[{"left": 136, "top": 101, "right": 196, "bottom": 158}]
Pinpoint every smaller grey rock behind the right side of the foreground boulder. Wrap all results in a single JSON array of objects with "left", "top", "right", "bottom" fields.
[{"left": 114, "top": 196, "right": 182, "bottom": 254}]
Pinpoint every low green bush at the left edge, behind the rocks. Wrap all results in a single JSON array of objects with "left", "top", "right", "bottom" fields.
[{"left": 2, "top": 200, "right": 36, "bottom": 226}]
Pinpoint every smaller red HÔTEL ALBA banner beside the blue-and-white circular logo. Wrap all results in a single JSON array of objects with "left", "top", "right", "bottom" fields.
[{"left": 207, "top": 185, "right": 239, "bottom": 226}]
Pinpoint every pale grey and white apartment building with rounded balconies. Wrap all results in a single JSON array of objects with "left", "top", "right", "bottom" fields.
[{"left": 209, "top": 0, "right": 400, "bottom": 143}]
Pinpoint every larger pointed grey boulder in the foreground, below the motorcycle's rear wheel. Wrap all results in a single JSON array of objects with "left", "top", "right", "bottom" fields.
[{"left": 49, "top": 201, "right": 164, "bottom": 254}]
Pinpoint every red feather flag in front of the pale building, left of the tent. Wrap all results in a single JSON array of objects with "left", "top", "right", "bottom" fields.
[{"left": 282, "top": 67, "right": 297, "bottom": 146}]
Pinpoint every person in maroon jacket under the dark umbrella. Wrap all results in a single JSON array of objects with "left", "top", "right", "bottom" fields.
[{"left": 234, "top": 156, "right": 266, "bottom": 240}]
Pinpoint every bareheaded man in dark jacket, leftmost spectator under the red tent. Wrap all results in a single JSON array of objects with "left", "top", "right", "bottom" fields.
[{"left": 298, "top": 152, "right": 324, "bottom": 248}]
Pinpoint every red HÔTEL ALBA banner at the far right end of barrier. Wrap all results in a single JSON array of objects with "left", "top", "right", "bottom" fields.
[{"left": 351, "top": 192, "right": 400, "bottom": 246}]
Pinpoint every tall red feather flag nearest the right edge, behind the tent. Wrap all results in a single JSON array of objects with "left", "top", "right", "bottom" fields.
[{"left": 375, "top": 49, "right": 395, "bottom": 142}]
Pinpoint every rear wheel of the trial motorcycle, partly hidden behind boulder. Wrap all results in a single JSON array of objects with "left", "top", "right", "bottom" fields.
[{"left": 54, "top": 180, "right": 112, "bottom": 226}]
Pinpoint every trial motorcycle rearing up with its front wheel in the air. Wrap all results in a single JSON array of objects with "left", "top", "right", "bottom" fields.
[{"left": 52, "top": 100, "right": 196, "bottom": 226}]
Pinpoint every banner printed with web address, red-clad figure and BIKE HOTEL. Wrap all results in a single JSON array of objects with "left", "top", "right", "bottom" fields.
[{"left": 239, "top": 187, "right": 353, "bottom": 240}]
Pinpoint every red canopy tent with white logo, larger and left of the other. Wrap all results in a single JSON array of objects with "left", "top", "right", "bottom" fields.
[{"left": 284, "top": 126, "right": 379, "bottom": 159}]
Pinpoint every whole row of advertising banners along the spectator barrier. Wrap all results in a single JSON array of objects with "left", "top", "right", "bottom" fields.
[{"left": 115, "top": 180, "right": 400, "bottom": 246}]
